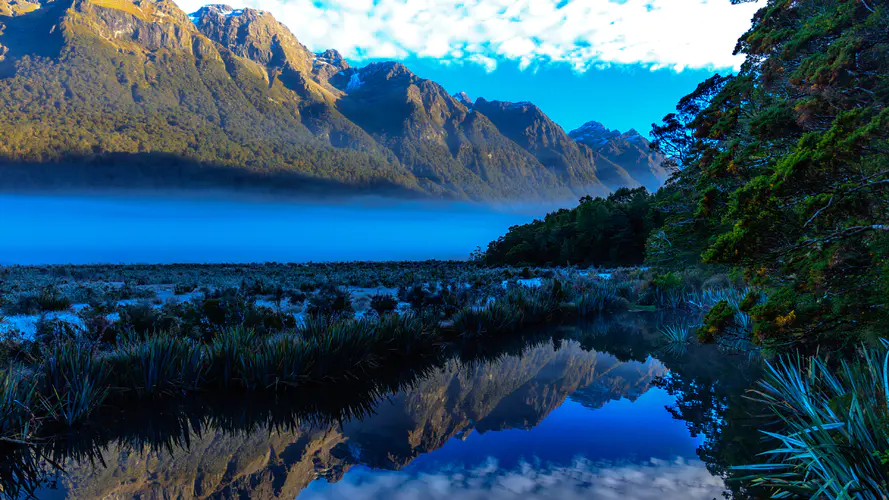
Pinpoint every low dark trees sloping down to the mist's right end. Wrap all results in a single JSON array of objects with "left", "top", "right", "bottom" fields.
[{"left": 484, "top": 188, "right": 658, "bottom": 267}]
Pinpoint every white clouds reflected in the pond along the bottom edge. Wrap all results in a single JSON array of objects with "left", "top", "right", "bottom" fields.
[{"left": 299, "top": 459, "right": 725, "bottom": 500}]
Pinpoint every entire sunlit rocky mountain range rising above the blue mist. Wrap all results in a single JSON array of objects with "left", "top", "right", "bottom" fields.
[{"left": 0, "top": 0, "right": 667, "bottom": 201}]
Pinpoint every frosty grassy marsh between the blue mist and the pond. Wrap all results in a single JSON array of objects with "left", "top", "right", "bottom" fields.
[{"left": 0, "top": 262, "right": 748, "bottom": 439}]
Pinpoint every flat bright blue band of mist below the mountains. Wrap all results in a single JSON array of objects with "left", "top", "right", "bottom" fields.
[{"left": 0, "top": 194, "right": 546, "bottom": 265}]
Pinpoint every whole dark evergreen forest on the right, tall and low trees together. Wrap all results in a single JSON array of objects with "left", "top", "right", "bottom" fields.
[{"left": 486, "top": 0, "right": 889, "bottom": 343}]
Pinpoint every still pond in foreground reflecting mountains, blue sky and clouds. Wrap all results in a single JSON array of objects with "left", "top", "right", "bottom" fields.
[{"left": 3, "top": 314, "right": 750, "bottom": 499}]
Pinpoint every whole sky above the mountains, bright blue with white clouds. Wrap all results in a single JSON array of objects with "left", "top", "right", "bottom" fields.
[{"left": 176, "top": 0, "right": 763, "bottom": 134}]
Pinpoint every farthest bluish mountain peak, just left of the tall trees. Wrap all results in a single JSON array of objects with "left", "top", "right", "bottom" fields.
[{"left": 568, "top": 121, "right": 670, "bottom": 192}]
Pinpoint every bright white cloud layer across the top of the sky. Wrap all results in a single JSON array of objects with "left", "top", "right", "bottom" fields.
[{"left": 177, "top": 0, "right": 762, "bottom": 72}]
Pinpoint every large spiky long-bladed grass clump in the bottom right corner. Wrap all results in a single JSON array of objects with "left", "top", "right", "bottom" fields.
[{"left": 738, "top": 342, "right": 889, "bottom": 500}]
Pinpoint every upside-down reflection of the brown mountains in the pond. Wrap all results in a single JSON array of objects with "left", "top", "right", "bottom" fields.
[{"left": 46, "top": 343, "right": 666, "bottom": 499}]
